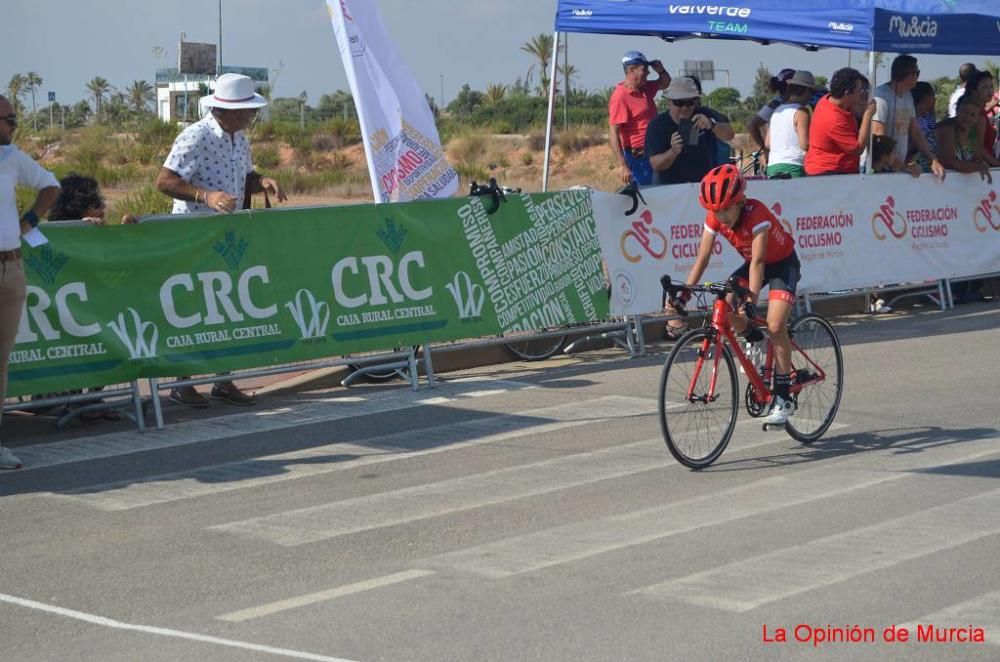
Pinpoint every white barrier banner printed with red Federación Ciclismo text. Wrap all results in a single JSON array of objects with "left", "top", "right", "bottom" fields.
[{"left": 592, "top": 172, "right": 1000, "bottom": 315}]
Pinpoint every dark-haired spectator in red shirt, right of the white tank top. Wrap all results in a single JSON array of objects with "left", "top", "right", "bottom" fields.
[{"left": 805, "top": 67, "right": 875, "bottom": 175}]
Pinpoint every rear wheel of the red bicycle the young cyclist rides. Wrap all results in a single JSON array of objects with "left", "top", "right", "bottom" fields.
[{"left": 785, "top": 313, "right": 844, "bottom": 443}]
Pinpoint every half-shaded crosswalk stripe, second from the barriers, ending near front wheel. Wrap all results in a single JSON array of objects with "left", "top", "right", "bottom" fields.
[{"left": 54, "top": 396, "right": 656, "bottom": 511}]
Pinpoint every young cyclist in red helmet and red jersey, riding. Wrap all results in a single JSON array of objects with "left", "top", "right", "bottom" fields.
[{"left": 681, "top": 164, "right": 800, "bottom": 425}]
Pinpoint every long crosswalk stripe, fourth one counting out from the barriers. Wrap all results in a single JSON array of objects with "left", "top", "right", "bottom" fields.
[{"left": 422, "top": 428, "right": 997, "bottom": 578}]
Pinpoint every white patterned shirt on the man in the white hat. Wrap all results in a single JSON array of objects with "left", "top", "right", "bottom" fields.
[{"left": 163, "top": 113, "right": 253, "bottom": 214}]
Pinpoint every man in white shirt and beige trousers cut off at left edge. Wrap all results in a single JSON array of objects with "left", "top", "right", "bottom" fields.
[{"left": 0, "top": 96, "right": 59, "bottom": 469}]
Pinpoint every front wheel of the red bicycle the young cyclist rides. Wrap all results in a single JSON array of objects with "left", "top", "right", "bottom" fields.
[{"left": 660, "top": 329, "right": 740, "bottom": 469}]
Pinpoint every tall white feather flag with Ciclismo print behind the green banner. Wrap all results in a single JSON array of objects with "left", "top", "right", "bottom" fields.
[{"left": 326, "top": 0, "right": 458, "bottom": 202}]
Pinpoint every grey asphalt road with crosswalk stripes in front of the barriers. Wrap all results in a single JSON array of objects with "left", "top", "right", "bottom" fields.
[{"left": 0, "top": 302, "right": 1000, "bottom": 662}]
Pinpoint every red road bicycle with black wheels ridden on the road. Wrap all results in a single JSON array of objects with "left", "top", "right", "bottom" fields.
[{"left": 659, "top": 276, "right": 844, "bottom": 469}]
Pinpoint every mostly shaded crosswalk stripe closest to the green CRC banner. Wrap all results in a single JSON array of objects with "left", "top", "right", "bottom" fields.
[{"left": 9, "top": 377, "right": 537, "bottom": 474}]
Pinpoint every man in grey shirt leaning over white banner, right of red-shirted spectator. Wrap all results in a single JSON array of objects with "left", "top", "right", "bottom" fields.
[{"left": 872, "top": 55, "right": 944, "bottom": 179}]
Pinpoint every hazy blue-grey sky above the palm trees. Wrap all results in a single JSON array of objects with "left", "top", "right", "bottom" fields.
[{"left": 0, "top": 0, "right": 983, "bottom": 109}]
